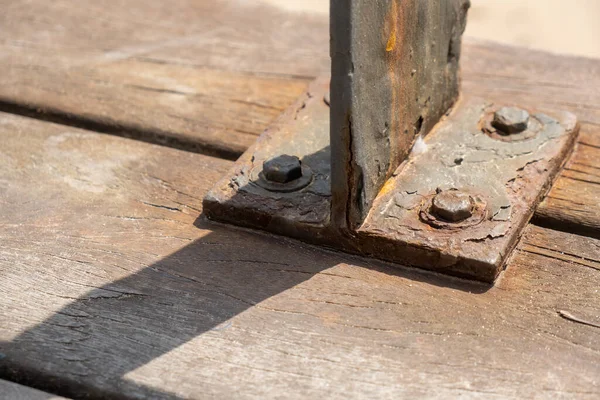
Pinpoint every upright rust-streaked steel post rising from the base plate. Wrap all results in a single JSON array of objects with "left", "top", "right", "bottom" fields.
[{"left": 331, "top": 0, "right": 470, "bottom": 231}]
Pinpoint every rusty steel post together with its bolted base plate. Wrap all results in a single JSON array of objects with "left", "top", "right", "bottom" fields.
[{"left": 204, "top": 0, "right": 579, "bottom": 283}]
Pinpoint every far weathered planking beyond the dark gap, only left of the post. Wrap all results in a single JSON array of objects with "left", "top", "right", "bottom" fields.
[{"left": 0, "top": 0, "right": 328, "bottom": 158}]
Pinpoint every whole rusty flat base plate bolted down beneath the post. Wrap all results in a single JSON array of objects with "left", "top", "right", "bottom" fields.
[{"left": 204, "top": 79, "right": 579, "bottom": 283}]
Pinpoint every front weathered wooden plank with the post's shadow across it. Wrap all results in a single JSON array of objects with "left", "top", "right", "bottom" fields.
[{"left": 0, "top": 114, "right": 600, "bottom": 399}]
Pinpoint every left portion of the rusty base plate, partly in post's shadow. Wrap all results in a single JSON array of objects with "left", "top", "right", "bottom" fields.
[{"left": 204, "top": 78, "right": 331, "bottom": 243}]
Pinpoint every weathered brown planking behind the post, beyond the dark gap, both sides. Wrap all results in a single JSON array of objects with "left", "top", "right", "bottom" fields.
[{"left": 0, "top": 0, "right": 600, "bottom": 234}]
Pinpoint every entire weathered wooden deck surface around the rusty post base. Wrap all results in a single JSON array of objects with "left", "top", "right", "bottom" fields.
[{"left": 0, "top": 0, "right": 600, "bottom": 399}]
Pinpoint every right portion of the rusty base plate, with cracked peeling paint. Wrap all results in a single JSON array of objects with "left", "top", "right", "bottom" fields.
[{"left": 359, "top": 98, "right": 579, "bottom": 282}]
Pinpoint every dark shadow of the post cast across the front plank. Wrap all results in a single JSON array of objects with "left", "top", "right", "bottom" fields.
[{"left": 0, "top": 216, "right": 488, "bottom": 399}]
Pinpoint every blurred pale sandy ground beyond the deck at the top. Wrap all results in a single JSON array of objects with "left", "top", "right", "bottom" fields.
[{"left": 263, "top": 0, "right": 600, "bottom": 57}]
